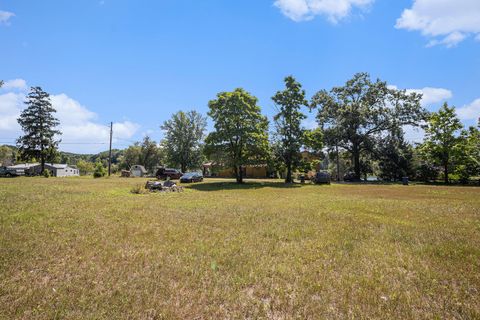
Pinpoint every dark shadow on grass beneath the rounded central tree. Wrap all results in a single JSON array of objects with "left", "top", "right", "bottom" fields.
[{"left": 186, "top": 181, "right": 301, "bottom": 191}]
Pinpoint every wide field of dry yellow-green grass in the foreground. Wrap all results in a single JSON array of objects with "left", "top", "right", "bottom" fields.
[{"left": 0, "top": 178, "right": 480, "bottom": 319}]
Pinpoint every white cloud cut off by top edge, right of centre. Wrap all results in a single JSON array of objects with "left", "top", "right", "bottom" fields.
[{"left": 274, "top": 0, "right": 375, "bottom": 23}]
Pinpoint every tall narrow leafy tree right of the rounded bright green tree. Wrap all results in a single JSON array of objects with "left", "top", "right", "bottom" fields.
[{"left": 272, "top": 76, "right": 308, "bottom": 183}]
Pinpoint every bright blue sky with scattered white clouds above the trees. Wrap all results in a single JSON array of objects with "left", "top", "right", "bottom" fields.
[{"left": 0, "top": 0, "right": 480, "bottom": 152}]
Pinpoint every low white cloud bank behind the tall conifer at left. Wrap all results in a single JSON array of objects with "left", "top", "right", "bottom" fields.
[{"left": 0, "top": 82, "right": 140, "bottom": 153}]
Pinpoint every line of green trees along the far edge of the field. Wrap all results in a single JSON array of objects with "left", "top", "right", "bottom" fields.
[{"left": 4, "top": 73, "right": 480, "bottom": 183}]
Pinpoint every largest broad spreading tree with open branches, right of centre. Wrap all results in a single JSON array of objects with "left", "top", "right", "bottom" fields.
[{"left": 311, "top": 73, "right": 425, "bottom": 179}]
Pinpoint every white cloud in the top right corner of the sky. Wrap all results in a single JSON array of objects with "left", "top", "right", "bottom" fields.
[{"left": 395, "top": 0, "right": 480, "bottom": 47}]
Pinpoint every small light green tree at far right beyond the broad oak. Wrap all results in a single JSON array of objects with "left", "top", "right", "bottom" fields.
[{"left": 421, "top": 103, "right": 463, "bottom": 183}]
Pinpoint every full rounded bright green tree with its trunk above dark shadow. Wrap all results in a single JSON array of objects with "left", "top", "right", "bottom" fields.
[{"left": 205, "top": 89, "right": 268, "bottom": 183}]
